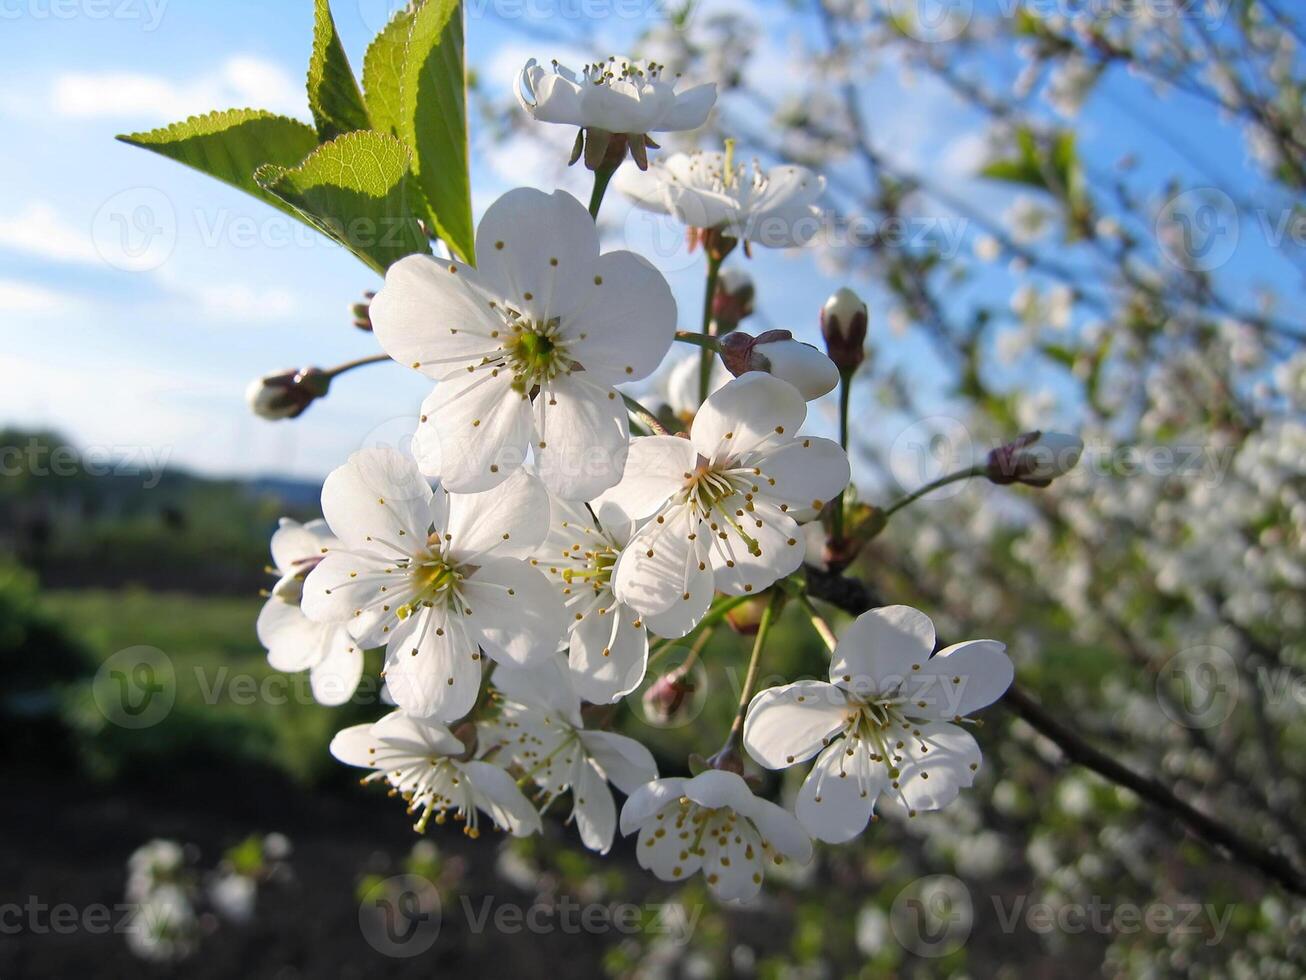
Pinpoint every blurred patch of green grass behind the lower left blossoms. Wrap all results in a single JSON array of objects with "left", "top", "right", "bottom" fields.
[{"left": 40, "top": 589, "right": 377, "bottom": 780}]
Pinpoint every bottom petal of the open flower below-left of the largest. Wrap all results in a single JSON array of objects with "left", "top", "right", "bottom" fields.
[{"left": 385, "top": 606, "right": 481, "bottom": 721}]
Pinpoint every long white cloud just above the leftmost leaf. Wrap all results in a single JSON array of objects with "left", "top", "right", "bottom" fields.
[{"left": 51, "top": 56, "right": 307, "bottom": 123}]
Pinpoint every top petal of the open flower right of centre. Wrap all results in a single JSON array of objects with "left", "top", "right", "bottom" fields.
[{"left": 690, "top": 371, "right": 807, "bottom": 460}]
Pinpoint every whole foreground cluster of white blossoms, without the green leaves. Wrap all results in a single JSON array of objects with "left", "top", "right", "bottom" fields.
[{"left": 246, "top": 59, "right": 1012, "bottom": 900}]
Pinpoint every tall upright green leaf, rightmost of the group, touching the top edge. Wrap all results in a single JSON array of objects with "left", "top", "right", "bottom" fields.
[{"left": 398, "top": 0, "right": 475, "bottom": 261}]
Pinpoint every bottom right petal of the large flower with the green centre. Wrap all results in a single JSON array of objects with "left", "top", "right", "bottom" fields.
[{"left": 534, "top": 374, "right": 631, "bottom": 500}]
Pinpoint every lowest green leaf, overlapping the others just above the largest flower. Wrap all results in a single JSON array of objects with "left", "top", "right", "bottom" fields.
[{"left": 255, "top": 129, "right": 431, "bottom": 274}]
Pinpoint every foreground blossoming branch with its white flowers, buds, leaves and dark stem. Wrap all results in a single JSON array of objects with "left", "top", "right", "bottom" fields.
[{"left": 123, "top": 0, "right": 1306, "bottom": 902}]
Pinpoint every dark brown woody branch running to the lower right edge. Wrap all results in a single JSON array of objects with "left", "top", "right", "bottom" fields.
[{"left": 807, "top": 568, "right": 1306, "bottom": 896}]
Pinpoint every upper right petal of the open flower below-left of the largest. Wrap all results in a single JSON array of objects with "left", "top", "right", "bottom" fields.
[{"left": 438, "top": 470, "right": 550, "bottom": 563}]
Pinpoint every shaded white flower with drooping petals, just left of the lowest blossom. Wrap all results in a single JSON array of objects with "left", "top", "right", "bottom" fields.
[{"left": 477, "top": 657, "right": 657, "bottom": 855}]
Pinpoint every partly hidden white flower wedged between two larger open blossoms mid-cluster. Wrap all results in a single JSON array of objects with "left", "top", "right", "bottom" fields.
[{"left": 535, "top": 498, "right": 692, "bottom": 704}]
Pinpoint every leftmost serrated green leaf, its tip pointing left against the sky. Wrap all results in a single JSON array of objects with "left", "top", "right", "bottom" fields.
[{"left": 118, "top": 108, "right": 317, "bottom": 217}]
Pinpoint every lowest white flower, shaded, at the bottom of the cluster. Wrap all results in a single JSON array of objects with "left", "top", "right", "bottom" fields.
[{"left": 622, "top": 770, "right": 812, "bottom": 902}]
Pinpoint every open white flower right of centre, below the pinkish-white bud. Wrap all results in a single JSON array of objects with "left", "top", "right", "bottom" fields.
[{"left": 599, "top": 372, "right": 849, "bottom": 626}]
